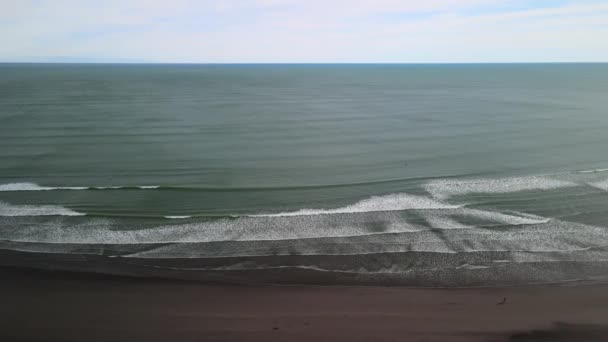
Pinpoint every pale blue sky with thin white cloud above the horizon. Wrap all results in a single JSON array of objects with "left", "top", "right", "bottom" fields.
[{"left": 0, "top": 0, "right": 608, "bottom": 63}]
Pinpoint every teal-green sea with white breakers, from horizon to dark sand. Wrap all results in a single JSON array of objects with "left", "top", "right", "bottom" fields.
[{"left": 0, "top": 64, "right": 608, "bottom": 286}]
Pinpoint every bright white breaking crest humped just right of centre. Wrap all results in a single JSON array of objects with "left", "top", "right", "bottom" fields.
[{"left": 250, "top": 193, "right": 461, "bottom": 217}]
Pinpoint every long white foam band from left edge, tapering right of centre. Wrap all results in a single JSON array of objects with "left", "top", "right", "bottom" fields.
[{"left": 0, "top": 212, "right": 428, "bottom": 244}]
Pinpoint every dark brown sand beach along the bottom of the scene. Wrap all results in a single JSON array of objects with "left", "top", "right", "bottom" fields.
[{"left": 0, "top": 268, "right": 608, "bottom": 341}]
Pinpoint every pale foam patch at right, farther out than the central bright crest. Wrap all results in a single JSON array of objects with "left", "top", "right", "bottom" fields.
[{"left": 424, "top": 176, "right": 577, "bottom": 200}]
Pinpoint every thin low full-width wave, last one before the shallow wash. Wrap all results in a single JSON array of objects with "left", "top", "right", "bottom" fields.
[{"left": 0, "top": 239, "right": 608, "bottom": 263}]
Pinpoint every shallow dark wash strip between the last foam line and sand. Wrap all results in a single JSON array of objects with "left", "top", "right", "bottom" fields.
[{"left": 0, "top": 246, "right": 608, "bottom": 289}]
